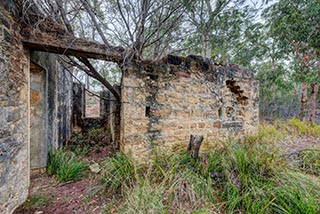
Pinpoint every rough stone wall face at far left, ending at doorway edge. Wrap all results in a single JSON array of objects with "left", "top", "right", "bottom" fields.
[{"left": 0, "top": 0, "right": 29, "bottom": 213}]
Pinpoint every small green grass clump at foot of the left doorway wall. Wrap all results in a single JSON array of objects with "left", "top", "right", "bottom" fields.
[{"left": 47, "top": 149, "right": 87, "bottom": 182}]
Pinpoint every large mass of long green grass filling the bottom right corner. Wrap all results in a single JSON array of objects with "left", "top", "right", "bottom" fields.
[{"left": 207, "top": 138, "right": 320, "bottom": 213}]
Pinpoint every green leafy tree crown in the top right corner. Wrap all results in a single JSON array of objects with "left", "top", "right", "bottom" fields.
[{"left": 264, "top": 0, "right": 320, "bottom": 82}]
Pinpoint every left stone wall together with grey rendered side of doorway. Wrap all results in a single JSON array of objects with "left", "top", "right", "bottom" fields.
[{"left": 0, "top": 0, "right": 72, "bottom": 213}]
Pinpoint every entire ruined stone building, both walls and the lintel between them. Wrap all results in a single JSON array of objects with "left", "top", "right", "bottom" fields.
[{"left": 0, "top": 0, "right": 258, "bottom": 213}]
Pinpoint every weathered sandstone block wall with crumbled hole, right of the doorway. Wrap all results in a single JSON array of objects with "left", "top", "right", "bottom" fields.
[{"left": 120, "top": 56, "right": 259, "bottom": 159}]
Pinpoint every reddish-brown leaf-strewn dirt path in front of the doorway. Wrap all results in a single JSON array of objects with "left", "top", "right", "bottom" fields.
[{"left": 15, "top": 173, "right": 111, "bottom": 214}]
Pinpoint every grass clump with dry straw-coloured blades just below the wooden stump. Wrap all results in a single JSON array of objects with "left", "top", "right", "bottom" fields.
[{"left": 152, "top": 154, "right": 216, "bottom": 213}]
